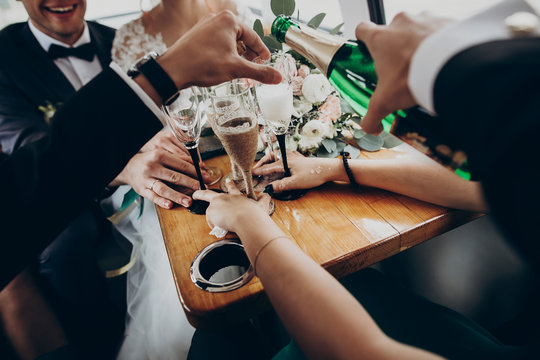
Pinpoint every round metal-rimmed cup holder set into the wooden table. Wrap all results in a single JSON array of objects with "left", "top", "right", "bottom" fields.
[{"left": 190, "top": 239, "right": 254, "bottom": 292}]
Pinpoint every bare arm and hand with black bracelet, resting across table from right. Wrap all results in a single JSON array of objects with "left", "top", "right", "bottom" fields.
[{"left": 253, "top": 148, "right": 487, "bottom": 212}]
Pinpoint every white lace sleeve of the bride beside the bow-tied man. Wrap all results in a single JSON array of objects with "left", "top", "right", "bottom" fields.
[{"left": 111, "top": 18, "right": 167, "bottom": 71}]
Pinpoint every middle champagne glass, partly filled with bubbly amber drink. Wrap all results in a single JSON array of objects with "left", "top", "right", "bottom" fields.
[{"left": 207, "top": 80, "right": 259, "bottom": 200}]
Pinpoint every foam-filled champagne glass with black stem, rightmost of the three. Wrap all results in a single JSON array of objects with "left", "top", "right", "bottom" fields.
[{"left": 256, "top": 53, "right": 306, "bottom": 201}]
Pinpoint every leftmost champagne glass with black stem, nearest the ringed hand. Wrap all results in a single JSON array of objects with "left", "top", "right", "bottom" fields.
[{"left": 161, "top": 89, "right": 209, "bottom": 215}]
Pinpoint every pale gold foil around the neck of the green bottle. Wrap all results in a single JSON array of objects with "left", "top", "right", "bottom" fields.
[{"left": 285, "top": 26, "right": 346, "bottom": 76}]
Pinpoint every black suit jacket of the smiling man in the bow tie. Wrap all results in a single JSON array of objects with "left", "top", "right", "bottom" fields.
[{"left": 0, "top": 21, "right": 114, "bottom": 153}]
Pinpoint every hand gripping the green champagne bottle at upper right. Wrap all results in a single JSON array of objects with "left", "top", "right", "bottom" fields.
[{"left": 356, "top": 13, "right": 449, "bottom": 134}]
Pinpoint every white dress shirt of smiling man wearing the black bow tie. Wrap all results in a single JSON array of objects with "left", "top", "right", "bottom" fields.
[{"left": 28, "top": 20, "right": 102, "bottom": 90}]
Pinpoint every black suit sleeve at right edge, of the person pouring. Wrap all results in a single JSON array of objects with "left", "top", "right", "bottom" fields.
[{"left": 434, "top": 38, "right": 540, "bottom": 262}]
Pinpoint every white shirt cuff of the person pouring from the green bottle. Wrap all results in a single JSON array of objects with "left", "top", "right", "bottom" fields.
[{"left": 408, "top": 0, "right": 534, "bottom": 114}]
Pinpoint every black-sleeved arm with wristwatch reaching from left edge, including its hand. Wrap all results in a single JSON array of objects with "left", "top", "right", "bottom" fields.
[{"left": 0, "top": 13, "right": 280, "bottom": 288}]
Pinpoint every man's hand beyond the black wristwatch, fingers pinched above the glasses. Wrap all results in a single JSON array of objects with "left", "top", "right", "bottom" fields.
[{"left": 158, "top": 11, "right": 281, "bottom": 89}]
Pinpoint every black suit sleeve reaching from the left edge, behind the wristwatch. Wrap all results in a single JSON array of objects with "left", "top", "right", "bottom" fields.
[{"left": 0, "top": 69, "right": 162, "bottom": 289}]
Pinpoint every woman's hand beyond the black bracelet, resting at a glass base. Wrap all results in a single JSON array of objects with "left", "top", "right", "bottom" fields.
[{"left": 253, "top": 151, "right": 341, "bottom": 193}]
